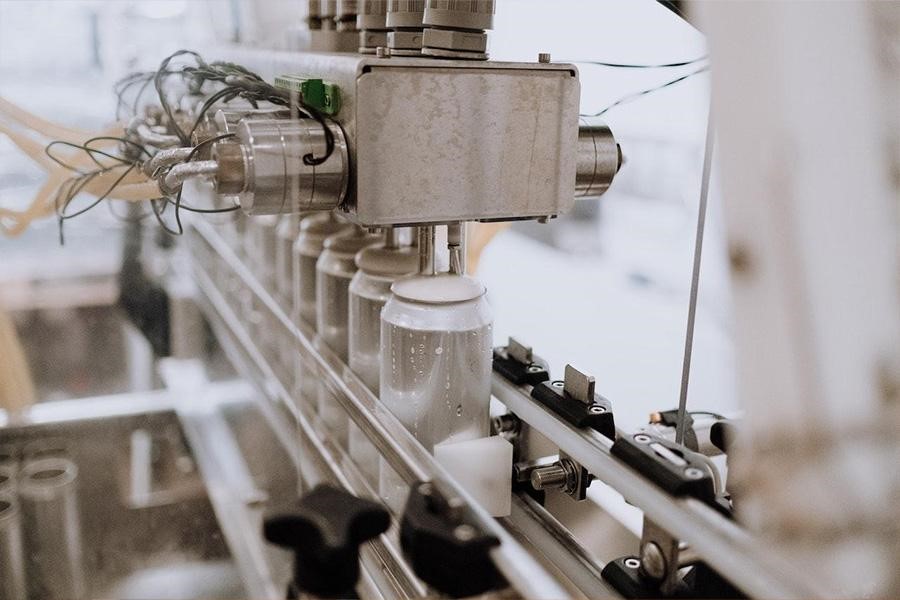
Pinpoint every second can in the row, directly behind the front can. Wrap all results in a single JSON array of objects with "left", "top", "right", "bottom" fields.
[{"left": 348, "top": 245, "right": 418, "bottom": 486}]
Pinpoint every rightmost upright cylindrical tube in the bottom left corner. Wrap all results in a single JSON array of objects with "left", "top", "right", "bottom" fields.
[{"left": 18, "top": 457, "right": 86, "bottom": 600}]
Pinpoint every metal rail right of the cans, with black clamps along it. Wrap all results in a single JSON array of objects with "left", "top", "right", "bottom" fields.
[{"left": 492, "top": 375, "right": 819, "bottom": 598}]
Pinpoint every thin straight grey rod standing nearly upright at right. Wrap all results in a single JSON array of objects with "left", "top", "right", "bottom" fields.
[{"left": 675, "top": 107, "right": 716, "bottom": 444}]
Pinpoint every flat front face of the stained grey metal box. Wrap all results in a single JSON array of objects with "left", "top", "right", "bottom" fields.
[{"left": 351, "top": 67, "right": 579, "bottom": 225}]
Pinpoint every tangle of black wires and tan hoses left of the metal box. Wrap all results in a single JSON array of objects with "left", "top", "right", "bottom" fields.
[{"left": 0, "top": 50, "right": 334, "bottom": 243}]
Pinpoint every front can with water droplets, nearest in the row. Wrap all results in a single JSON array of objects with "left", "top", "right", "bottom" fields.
[{"left": 379, "top": 274, "right": 493, "bottom": 506}]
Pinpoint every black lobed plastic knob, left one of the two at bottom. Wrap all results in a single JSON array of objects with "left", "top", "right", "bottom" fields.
[{"left": 264, "top": 485, "right": 391, "bottom": 598}]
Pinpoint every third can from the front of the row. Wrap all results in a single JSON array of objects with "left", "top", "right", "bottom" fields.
[{"left": 316, "top": 228, "right": 382, "bottom": 446}]
